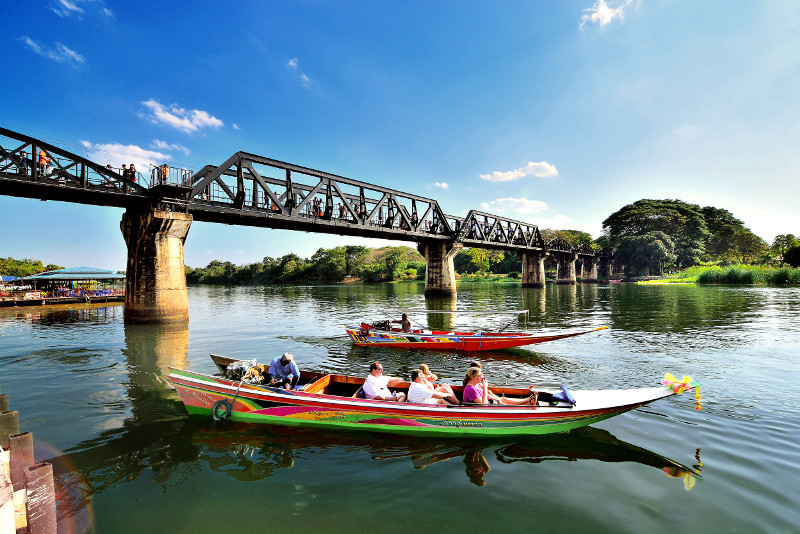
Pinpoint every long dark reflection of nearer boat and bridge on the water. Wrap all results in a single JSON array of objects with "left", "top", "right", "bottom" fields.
[{"left": 48, "top": 418, "right": 699, "bottom": 510}]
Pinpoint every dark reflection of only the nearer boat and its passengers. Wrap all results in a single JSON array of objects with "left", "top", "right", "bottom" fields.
[{"left": 191, "top": 422, "right": 700, "bottom": 491}]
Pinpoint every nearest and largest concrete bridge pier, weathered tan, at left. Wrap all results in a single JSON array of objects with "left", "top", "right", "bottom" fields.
[{"left": 120, "top": 208, "right": 192, "bottom": 323}]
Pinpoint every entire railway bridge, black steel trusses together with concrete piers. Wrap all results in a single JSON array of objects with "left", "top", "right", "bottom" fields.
[{"left": 0, "top": 127, "right": 610, "bottom": 322}]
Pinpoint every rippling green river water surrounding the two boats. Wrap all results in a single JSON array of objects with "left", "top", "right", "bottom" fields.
[{"left": 0, "top": 283, "right": 800, "bottom": 534}]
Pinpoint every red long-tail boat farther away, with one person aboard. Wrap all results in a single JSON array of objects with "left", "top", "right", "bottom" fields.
[{"left": 344, "top": 321, "right": 608, "bottom": 351}]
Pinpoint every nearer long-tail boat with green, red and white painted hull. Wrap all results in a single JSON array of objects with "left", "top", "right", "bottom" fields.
[{"left": 169, "top": 355, "right": 699, "bottom": 437}]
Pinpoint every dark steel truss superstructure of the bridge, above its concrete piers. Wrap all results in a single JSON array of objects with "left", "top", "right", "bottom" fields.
[{"left": 0, "top": 127, "right": 597, "bottom": 257}]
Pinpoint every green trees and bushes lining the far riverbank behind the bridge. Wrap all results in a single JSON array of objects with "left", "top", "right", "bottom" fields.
[{"left": 0, "top": 199, "right": 800, "bottom": 285}]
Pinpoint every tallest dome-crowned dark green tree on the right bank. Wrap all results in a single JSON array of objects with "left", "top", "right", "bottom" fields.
[{"left": 603, "top": 199, "right": 710, "bottom": 267}]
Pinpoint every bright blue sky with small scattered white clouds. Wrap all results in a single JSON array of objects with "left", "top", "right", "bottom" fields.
[{"left": 0, "top": 0, "right": 800, "bottom": 269}]
